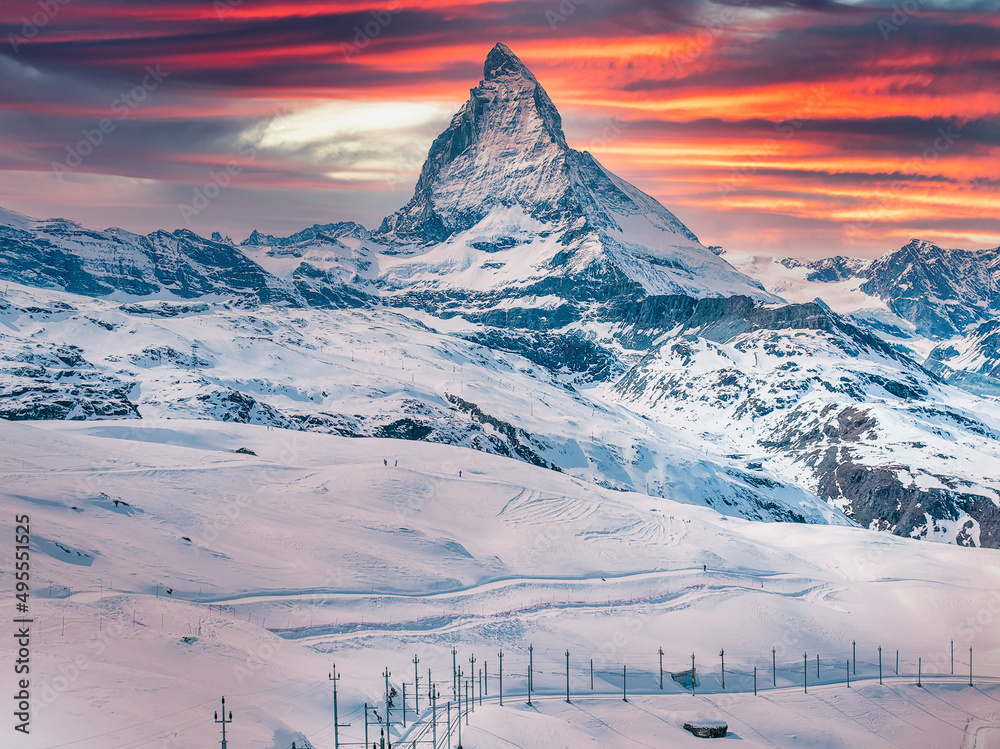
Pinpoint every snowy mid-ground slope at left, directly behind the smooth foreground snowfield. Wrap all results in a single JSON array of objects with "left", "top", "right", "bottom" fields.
[{"left": 0, "top": 278, "right": 847, "bottom": 522}]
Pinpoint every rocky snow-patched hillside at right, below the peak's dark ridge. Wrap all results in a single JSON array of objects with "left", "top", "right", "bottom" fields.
[{"left": 610, "top": 304, "right": 1000, "bottom": 546}]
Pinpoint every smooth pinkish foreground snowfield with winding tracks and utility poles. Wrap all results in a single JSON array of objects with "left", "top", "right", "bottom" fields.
[{"left": 0, "top": 419, "right": 1000, "bottom": 749}]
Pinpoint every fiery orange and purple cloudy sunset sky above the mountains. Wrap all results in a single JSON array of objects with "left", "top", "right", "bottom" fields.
[{"left": 0, "top": 0, "right": 1000, "bottom": 257}]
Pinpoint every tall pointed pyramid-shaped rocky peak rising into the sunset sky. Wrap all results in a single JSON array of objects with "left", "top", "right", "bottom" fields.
[{"left": 373, "top": 44, "right": 776, "bottom": 301}]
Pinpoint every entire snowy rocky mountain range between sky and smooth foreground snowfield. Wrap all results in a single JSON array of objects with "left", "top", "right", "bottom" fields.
[{"left": 0, "top": 44, "right": 1000, "bottom": 547}]
